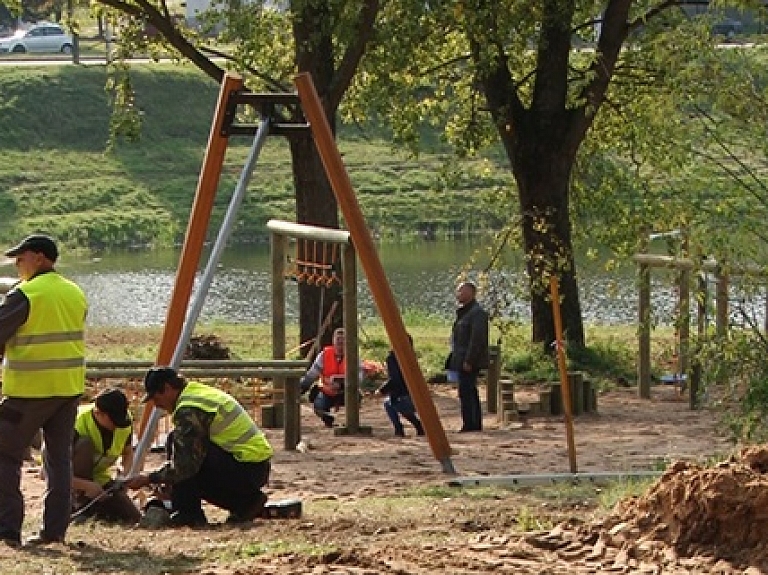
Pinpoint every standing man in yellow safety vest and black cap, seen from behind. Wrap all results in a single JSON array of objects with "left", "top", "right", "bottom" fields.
[{"left": 0, "top": 234, "right": 87, "bottom": 546}]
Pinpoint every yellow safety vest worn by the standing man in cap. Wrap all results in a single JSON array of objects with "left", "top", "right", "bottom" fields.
[{"left": 3, "top": 271, "right": 88, "bottom": 398}]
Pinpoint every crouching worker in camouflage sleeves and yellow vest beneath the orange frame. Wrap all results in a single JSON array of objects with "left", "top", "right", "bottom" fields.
[{"left": 128, "top": 367, "right": 272, "bottom": 527}]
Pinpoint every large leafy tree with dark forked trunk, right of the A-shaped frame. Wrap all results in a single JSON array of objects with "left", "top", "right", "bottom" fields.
[{"left": 359, "top": 0, "right": 736, "bottom": 346}]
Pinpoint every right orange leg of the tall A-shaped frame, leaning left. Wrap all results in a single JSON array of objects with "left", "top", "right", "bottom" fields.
[{"left": 294, "top": 72, "right": 455, "bottom": 473}]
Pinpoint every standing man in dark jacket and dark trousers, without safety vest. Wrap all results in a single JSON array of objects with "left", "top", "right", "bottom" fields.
[{"left": 447, "top": 282, "right": 488, "bottom": 433}]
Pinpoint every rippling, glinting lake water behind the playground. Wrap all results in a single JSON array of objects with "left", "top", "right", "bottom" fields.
[{"left": 0, "top": 240, "right": 744, "bottom": 327}]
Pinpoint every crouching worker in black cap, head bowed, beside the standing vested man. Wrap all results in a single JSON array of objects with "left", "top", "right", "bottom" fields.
[{"left": 72, "top": 389, "right": 141, "bottom": 524}]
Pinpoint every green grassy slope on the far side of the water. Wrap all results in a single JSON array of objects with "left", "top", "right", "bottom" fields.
[{"left": 0, "top": 65, "right": 511, "bottom": 251}]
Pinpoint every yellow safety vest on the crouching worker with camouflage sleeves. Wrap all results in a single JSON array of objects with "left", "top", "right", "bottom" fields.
[{"left": 173, "top": 381, "right": 273, "bottom": 463}]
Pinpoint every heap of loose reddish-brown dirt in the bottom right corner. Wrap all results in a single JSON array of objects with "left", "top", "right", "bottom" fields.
[{"left": 527, "top": 446, "right": 768, "bottom": 573}]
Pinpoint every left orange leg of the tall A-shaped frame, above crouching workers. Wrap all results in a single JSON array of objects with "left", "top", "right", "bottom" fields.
[{"left": 138, "top": 73, "right": 243, "bottom": 437}]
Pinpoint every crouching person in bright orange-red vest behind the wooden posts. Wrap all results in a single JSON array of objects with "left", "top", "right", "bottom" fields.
[{"left": 300, "top": 328, "right": 362, "bottom": 427}]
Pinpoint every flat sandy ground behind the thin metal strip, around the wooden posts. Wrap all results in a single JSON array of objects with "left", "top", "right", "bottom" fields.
[{"left": 269, "top": 386, "right": 732, "bottom": 497}]
